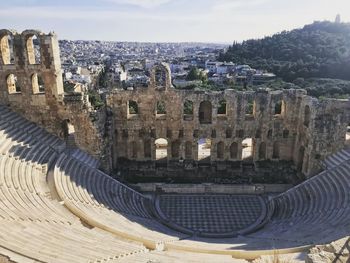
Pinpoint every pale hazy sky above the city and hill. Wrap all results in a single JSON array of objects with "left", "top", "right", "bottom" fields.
[{"left": 0, "top": 0, "right": 350, "bottom": 43}]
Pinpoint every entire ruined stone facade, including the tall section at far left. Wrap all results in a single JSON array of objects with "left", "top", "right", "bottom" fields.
[{"left": 0, "top": 30, "right": 350, "bottom": 182}]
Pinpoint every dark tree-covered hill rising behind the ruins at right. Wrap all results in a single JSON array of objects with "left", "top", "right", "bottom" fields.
[{"left": 218, "top": 21, "right": 350, "bottom": 81}]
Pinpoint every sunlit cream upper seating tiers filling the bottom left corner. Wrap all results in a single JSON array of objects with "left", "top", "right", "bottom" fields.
[{"left": 0, "top": 155, "right": 147, "bottom": 262}]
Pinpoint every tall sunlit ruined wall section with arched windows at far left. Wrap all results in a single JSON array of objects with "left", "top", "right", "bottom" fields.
[{"left": 0, "top": 30, "right": 104, "bottom": 165}]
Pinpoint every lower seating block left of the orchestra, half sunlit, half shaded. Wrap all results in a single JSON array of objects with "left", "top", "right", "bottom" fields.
[{"left": 54, "top": 154, "right": 186, "bottom": 251}]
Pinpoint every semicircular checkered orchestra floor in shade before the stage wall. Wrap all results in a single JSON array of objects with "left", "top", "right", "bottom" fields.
[{"left": 156, "top": 194, "right": 266, "bottom": 237}]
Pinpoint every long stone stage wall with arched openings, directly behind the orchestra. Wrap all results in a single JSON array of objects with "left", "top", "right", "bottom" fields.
[{"left": 107, "top": 64, "right": 348, "bottom": 180}]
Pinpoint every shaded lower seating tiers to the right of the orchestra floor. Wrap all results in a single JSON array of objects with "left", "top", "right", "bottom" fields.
[{"left": 253, "top": 161, "right": 350, "bottom": 244}]
